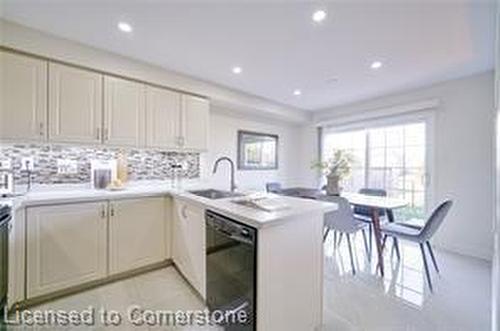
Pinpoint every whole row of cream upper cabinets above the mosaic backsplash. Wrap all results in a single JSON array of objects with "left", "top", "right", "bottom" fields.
[{"left": 0, "top": 51, "right": 210, "bottom": 152}]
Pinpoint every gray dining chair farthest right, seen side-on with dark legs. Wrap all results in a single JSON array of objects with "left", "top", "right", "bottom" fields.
[{"left": 381, "top": 200, "right": 453, "bottom": 292}]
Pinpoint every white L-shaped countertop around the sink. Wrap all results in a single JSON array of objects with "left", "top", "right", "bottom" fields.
[{"left": 0, "top": 181, "right": 337, "bottom": 228}]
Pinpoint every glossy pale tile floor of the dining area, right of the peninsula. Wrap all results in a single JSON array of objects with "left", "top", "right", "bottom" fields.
[{"left": 324, "top": 234, "right": 491, "bottom": 331}]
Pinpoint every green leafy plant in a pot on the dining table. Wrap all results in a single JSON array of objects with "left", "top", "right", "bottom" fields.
[{"left": 312, "top": 149, "right": 354, "bottom": 195}]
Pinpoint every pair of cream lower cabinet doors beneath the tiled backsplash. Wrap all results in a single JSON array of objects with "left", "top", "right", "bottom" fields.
[{"left": 26, "top": 197, "right": 171, "bottom": 299}]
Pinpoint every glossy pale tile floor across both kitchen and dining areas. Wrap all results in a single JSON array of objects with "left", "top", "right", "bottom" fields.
[{"left": 1, "top": 236, "right": 491, "bottom": 331}]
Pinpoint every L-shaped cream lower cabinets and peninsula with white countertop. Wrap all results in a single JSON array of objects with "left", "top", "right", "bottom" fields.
[{"left": 4, "top": 181, "right": 336, "bottom": 331}]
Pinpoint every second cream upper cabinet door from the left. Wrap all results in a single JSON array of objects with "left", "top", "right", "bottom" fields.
[{"left": 49, "top": 63, "right": 102, "bottom": 143}]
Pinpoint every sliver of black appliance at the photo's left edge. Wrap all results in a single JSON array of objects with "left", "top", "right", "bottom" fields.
[{"left": 0, "top": 205, "right": 12, "bottom": 324}]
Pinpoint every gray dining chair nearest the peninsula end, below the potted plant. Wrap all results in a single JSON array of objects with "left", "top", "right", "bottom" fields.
[{"left": 318, "top": 196, "right": 369, "bottom": 275}]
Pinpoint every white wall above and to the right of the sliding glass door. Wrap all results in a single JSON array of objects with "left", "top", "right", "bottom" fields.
[{"left": 312, "top": 72, "right": 495, "bottom": 260}]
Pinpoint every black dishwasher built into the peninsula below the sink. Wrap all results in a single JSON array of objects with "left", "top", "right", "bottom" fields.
[{"left": 205, "top": 210, "right": 257, "bottom": 331}]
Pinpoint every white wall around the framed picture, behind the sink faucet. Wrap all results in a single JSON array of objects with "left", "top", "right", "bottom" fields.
[{"left": 202, "top": 107, "right": 301, "bottom": 190}]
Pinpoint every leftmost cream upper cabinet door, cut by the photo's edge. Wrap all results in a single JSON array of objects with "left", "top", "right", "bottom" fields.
[{"left": 0, "top": 51, "right": 47, "bottom": 141}]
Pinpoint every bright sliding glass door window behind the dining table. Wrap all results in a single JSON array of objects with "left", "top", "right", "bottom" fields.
[{"left": 322, "top": 122, "right": 427, "bottom": 218}]
